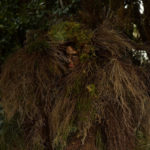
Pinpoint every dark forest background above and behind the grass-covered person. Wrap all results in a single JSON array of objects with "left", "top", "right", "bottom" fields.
[{"left": 0, "top": 0, "right": 150, "bottom": 61}]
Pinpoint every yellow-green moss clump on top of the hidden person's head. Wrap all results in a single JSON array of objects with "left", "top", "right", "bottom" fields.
[{"left": 49, "top": 21, "right": 93, "bottom": 47}]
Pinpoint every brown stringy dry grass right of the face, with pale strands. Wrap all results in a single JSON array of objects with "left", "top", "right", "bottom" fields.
[{"left": 50, "top": 25, "right": 149, "bottom": 150}]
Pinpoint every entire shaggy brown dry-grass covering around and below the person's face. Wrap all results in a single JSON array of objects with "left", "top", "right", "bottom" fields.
[{"left": 0, "top": 21, "right": 149, "bottom": 150}]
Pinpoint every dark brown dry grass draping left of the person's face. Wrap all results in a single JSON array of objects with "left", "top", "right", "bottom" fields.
[{"left": 1, "top": 32, "right": 65, "bottom": 150}]
